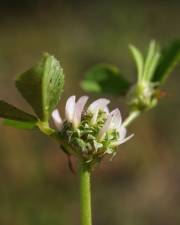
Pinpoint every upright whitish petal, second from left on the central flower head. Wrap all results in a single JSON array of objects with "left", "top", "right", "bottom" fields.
[{"left": 65, "top": 95, "right": 76, "bottom": 122}]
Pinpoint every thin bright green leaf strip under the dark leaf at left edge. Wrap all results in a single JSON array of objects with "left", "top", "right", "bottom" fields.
[{"left": 3, "top": 119, "right": 37, "bottom": 130}]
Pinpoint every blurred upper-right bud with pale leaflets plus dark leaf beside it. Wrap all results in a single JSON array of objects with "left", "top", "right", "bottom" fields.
[{"left": 128, "top": 40, "right": 180, "bottom": 112}]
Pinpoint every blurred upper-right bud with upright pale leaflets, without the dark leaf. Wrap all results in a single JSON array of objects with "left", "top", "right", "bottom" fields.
[{"left": 128, "top": 41, "right": 161, "bottom": 111}]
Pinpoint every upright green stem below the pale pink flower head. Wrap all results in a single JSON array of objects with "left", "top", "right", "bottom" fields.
[{"left": 79, "top": 163, "right": 92, "bottom": 225}]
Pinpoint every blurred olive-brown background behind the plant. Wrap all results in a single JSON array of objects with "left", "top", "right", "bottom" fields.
[{"left": 0, "top": 0, "right": 180, "bottom": 225}]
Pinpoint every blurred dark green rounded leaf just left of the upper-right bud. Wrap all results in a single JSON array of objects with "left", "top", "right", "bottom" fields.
[{"left": 81, "top": 64, "right": 130, "bottom": 95}]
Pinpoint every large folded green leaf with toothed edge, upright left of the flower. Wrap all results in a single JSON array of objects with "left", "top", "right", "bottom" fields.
[{"left": 16, "top": 53, "right": 64, "bottom": 121}]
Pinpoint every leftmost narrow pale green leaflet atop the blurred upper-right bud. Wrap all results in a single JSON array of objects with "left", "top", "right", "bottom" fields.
[{"left": 129, "top": 45, "right": 144, "bottom": 81}]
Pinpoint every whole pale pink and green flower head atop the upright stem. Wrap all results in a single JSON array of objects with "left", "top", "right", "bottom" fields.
[{"left": 52, "top": 96, "right": 133, "bottom": 163}]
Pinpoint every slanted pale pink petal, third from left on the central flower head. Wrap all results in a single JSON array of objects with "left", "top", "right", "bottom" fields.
[{"left": 73, "top": 96, "right": 89, "bottom": 128}]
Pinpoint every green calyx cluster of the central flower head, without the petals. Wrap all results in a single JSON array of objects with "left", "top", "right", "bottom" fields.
[{"left": 61, "top": 112, "right": 119, "bottom": 166}]
